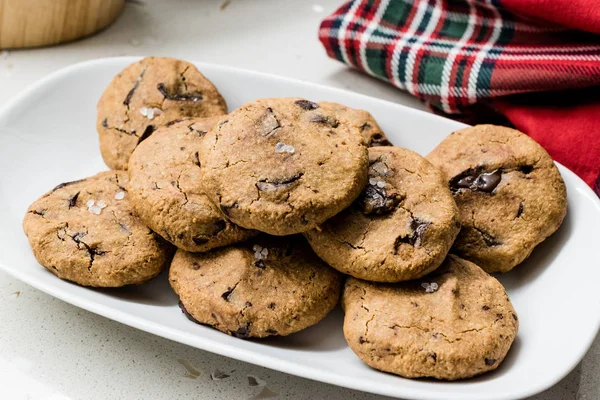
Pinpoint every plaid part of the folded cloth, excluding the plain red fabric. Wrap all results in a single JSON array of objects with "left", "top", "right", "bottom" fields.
[{"left": 319, "top": 0, "right": 600, "bottom": 113}]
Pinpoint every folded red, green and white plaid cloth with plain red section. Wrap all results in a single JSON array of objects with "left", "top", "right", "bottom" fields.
[{"left": 319, "top": 0, "right": 600, "bottom": 195}]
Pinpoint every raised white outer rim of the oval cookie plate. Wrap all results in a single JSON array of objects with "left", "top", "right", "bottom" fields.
[{"left": 0, "top": 56, "right": 600, "bottom": 400}]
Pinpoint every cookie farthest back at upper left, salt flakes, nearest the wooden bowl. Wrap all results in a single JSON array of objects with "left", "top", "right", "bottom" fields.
[{"left": 96, "top": 57, "right": 227, "bottom": 170}]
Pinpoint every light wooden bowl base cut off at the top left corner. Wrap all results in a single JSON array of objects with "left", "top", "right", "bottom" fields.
[{"left": 0, "top": 0, "right": 125, "bottom": 49}]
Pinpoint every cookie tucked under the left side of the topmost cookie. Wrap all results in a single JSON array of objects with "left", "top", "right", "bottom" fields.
[{"left": 128, "top": 117, "right": 256, "bottom": 252}]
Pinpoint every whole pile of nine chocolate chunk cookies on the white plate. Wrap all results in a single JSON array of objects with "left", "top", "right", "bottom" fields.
[{"left": 23, "top": 57, "right": 566, "bottom": 380}]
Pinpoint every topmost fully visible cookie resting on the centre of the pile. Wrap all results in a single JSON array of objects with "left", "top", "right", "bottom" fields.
[{"left": 200, "top": 98, "right": 368, "bottom": 235}]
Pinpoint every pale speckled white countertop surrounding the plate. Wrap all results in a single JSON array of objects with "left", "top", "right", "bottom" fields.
[{"left": 0, "top": 0, "right": 600, "bottom": 400}]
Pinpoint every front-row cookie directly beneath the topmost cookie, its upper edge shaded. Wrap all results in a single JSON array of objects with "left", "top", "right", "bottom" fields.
[{"left": 169, "top": 235, "right": 341, "bottom": 338}]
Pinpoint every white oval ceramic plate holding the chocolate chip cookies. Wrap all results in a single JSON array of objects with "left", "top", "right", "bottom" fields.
[{"left": 0, "top": 58, "right": 600, "bottom": 400}]
